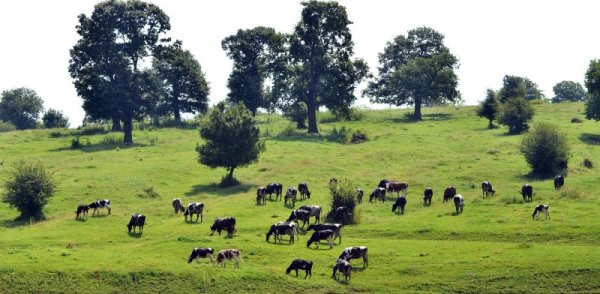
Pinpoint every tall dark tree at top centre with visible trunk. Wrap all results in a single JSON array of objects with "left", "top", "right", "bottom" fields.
[{"left": 284, "top": 0, "right": 368, "bottom": 133}]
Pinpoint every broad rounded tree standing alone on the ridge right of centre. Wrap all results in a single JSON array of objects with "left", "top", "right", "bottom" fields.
[{"left": 364, "top": 27, "right": 460, "bottom": 120}]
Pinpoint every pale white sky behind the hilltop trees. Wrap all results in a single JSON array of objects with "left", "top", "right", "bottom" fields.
[{"left": 0, "top": 0, "right": 600, "bottom": 126}]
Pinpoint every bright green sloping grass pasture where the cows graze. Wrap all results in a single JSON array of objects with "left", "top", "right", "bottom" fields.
[{"left": 0, "top": 103, "right": 600, "bottom": 293}]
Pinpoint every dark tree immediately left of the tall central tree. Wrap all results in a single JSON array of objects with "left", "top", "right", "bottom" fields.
[{"left": 221, "top": 27, "right": 286, "bottom": 115}]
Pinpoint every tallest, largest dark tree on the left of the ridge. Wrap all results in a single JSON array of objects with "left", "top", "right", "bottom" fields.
[{"left": 69, "top": 0, "right": 170, "bottom": 144}]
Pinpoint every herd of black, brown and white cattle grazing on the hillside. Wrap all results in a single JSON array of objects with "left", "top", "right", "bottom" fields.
[{"left": 75, "top": 175, "right": 564, "bottom": 280}]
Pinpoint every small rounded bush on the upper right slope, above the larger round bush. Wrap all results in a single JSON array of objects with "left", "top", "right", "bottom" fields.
[{"left": 498, "top": 97, "right": 534, "bottom": 134}]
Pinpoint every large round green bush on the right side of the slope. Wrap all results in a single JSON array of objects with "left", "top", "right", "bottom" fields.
[{"left": 520, "top": 123, "right": 570, "bottom": 176}]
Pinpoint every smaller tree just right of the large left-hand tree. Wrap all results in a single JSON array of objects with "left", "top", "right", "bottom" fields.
[{"left": 152, "top": 41, "right": 210, "bottom": 123}]
